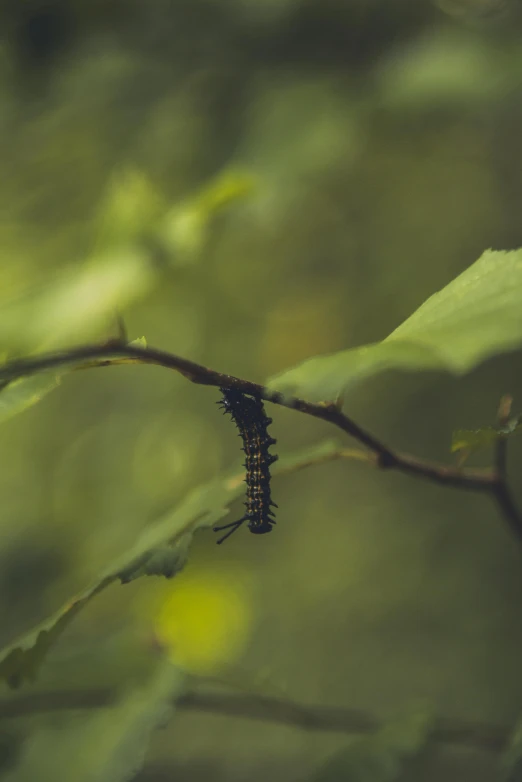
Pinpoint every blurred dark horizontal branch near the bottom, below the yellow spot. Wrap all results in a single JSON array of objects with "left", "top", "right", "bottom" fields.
[{"left": 0, "top": 688, "right": 510, "bottom": 752}]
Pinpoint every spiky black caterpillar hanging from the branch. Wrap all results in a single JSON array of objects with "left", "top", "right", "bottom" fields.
[{"left": 214, "top": 388, "right": 278, "bottom": 543}]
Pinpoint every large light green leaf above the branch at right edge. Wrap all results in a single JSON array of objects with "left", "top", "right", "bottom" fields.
[{"left": 268, "top": 250, "right": 522, "bottom": 401}]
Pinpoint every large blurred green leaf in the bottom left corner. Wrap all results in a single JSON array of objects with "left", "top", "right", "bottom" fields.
[{"left": 3, "top": 660, "right": 183, "bottom": 782}]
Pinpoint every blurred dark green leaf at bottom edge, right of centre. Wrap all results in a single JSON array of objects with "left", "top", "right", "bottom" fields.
[{"left": 314, "top": 712, "right": 430, "bottom": 782}]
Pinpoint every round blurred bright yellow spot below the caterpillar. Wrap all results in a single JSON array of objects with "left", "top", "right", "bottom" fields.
[{"left": 151, "top": 570, "right": 251, "bottom": 674}]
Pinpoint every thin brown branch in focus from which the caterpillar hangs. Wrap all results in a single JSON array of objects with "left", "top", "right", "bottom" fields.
[{"left": 0, "top": 339, "right": 522, "bottom": 528}]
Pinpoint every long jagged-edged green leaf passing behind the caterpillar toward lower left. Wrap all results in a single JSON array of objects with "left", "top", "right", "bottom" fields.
[{"left": 0, "top": 441, "right": 338, "bottom": 687}]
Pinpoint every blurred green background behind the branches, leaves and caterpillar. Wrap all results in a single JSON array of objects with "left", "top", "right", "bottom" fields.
[{"left": 0, "top": 0, "right": 522, "bottom": 782}]
